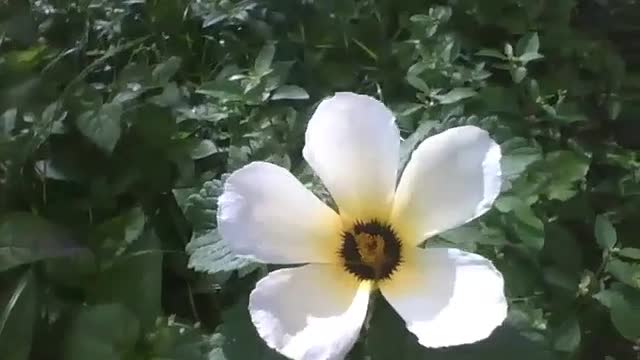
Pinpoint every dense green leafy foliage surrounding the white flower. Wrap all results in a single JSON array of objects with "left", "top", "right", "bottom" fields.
[{"left": 0, "top": 0, "right": 640, "bottom": 360}]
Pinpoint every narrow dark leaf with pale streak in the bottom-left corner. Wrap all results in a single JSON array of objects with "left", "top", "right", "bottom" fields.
[{"left": 0, "top": 270, "right": 38, "bottom": 360}]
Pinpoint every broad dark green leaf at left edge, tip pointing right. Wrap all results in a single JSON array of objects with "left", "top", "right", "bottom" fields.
[{"left": 0, "top": 212, "right": 82, "bottom": 271}]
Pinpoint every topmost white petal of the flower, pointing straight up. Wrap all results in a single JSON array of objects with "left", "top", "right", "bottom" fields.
[{"left": 302, "top": 93, "right": 400, "bottom": 218}]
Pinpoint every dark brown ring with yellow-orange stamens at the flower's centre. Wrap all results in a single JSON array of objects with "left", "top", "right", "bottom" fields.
[{"left": 339, "top": 219, "right": 402, "bottom": 281}]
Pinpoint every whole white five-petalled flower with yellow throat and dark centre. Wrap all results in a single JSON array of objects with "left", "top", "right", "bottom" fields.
[{"left": 218, "top": 93, "right": 507, "bottom": 360}]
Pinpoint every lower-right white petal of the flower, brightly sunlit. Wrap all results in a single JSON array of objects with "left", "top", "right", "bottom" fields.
[{"left": 380, "top": 248, "right": 507, "bottom": 347}]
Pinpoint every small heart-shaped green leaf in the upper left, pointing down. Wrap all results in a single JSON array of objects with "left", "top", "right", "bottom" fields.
[{"left": 76, "top": 103, "right": 122, "bottom": 154}]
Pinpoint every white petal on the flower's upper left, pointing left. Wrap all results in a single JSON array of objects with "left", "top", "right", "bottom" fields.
[{"left": 218, "top": 162, "right": 341, "bottom": 264}]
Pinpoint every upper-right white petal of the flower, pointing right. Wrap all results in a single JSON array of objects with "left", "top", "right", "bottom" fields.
[{"left": 392, "top": 126, "right": 502, "bottom": 243}]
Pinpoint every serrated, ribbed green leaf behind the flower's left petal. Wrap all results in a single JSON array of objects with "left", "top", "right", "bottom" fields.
[{"left": 185, "top": 180, "right": 257, "bottom": 276}]
